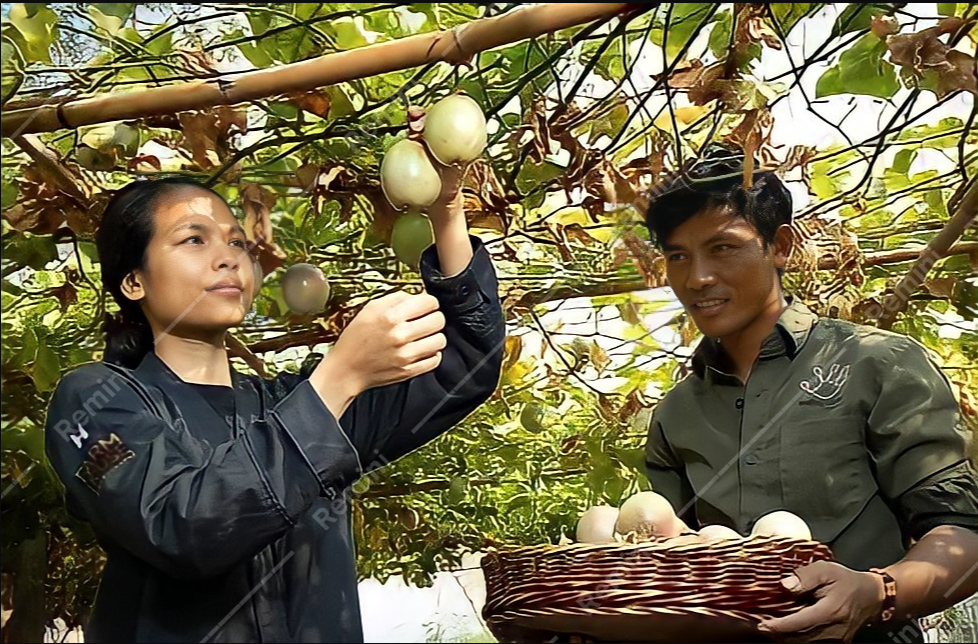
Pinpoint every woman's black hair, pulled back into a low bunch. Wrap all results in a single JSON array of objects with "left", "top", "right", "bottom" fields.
[{"left": 95, "top": 177, "right": 230, "bottom": 369}]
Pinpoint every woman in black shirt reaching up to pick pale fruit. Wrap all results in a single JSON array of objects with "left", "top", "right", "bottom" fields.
[{"left": 46, "top": 162, "right": 504, "bottom": 642}]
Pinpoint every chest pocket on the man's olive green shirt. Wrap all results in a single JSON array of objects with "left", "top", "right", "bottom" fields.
[{"left": 779, "top": 413, "right": 876, "bottom": 542}]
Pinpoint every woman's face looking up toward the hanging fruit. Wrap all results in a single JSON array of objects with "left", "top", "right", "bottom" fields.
[{"left": 122, "top": 186, "right": 257, "bottom": 340}]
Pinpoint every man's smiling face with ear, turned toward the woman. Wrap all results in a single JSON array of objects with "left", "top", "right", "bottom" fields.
[{"left": 663, "top": 206, "right": 791, "bottom": 340}]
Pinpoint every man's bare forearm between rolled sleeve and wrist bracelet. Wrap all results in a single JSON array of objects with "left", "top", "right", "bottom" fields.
[{"left": 886, "top": 526, "right": 978, "bottom": 619}]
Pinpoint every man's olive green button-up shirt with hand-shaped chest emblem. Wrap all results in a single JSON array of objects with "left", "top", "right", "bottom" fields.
[{"left": 646, "top": 301, "right": 973, "bottom": 570}]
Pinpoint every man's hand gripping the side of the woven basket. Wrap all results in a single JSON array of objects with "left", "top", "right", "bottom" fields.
[{"left": 758, "top": 561, "right": 884, "bottom": 642}]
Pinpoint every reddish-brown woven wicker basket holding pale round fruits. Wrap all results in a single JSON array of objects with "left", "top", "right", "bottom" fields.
[{"left": 481, "top": 536, "right": 832, "bottom": 642}]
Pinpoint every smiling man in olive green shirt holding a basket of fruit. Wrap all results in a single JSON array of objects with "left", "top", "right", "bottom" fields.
[{"left": 646, "top": 148, "right": 978, "bottom": 642}]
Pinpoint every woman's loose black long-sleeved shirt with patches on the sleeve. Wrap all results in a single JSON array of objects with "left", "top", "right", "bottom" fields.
[{"left": 45, "top": 237, "right": 505, "bottom": 642}]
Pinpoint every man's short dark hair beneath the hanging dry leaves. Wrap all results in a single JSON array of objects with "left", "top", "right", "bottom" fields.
[{"left": 645, "top": 144, "right": 791, "bottom": 249}]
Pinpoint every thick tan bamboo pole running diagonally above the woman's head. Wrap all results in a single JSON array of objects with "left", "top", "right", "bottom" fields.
[{"left": 0, "top": 2, "right": 644, "bottom": 136}]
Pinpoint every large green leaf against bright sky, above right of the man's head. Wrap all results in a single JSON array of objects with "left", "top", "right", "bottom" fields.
[{"left": 815, "top": 33, "right": 900, "bottom": 98}]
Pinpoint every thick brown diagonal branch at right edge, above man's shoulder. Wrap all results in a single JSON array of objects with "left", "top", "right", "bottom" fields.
[{"left": 878, "top": 180, "right": 978, "bottom": 329}]
